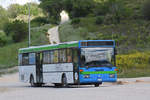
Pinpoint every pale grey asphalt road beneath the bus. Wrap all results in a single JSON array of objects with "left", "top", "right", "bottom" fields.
[{"left": 0, "top": 74, "right": 150, "bottom": 100}]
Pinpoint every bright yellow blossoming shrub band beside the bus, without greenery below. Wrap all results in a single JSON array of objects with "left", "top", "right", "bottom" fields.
[{"left": 116, "top": 52, "right": 150, "bottom": 72}]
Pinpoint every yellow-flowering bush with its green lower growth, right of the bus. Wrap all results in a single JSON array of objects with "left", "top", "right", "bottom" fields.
[{"left": 116, "top": 52, "right": 150, "bottom": 77}]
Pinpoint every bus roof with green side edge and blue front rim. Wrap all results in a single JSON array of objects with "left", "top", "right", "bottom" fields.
[{"left": 19, "top": 40, "right": 115, "bottom": 53}]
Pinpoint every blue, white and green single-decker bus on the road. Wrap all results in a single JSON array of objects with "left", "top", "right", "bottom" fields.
[{"left": 18, "top": 40, "right": 117, "bottom": 87}]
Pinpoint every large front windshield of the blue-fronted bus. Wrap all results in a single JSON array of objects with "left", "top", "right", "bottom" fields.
[{"left": 81, "top": 48, "right": 114, "bottom": 67}]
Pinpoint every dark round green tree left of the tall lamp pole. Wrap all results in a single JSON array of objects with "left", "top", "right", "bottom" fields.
[{"left": 4, "top": 20, "right": 28, "bottom": 42}]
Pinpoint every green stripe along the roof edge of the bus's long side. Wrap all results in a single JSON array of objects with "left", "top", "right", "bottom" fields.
[{"left": 19, "top": 43, "right": 78, "bottom": 53}]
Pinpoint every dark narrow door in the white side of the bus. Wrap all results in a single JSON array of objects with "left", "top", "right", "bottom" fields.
[{"left": 36, "top": 53, "right": 43, "bottom": 83}]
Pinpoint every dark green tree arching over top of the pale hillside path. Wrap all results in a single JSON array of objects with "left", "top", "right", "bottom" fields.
[{"left": 40, "top": 0, "right": 95, "bottom": 20}]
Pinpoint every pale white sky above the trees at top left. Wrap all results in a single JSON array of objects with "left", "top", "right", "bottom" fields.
[{"left": 0, "top": 0, "right": 39, "bottom": 8}]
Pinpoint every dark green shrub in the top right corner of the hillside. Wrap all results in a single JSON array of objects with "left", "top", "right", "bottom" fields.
[{"left": 142, "top": 0, "right": 150, "bottom": 20}]
